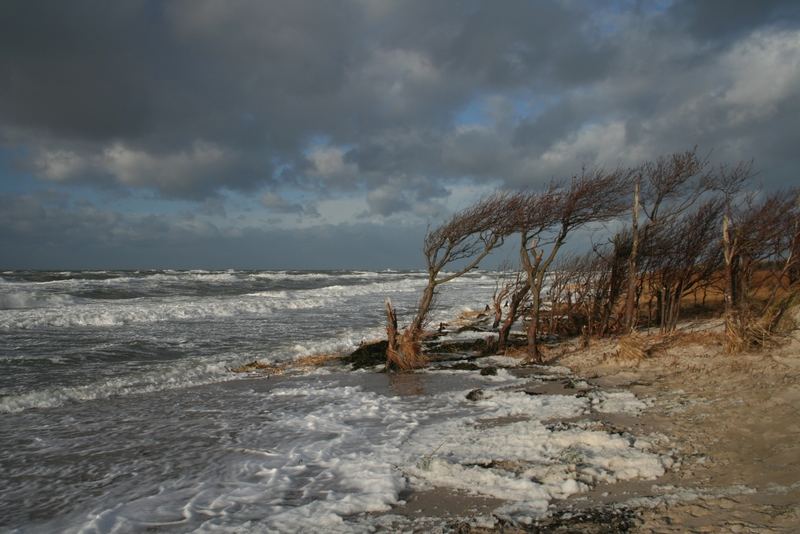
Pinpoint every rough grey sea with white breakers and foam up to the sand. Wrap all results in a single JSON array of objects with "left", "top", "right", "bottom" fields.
[{"left": 0, "top": 270, "right": 663, "bottom": 533}]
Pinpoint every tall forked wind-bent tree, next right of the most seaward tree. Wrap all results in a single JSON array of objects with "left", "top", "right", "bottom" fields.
[{"left": 519, "top": 169, "right": 632, "bottom": 361}]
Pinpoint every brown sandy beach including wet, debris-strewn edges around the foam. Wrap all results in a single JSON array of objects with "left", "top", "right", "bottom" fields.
[{"left": 360, "top": 314, "right": 800, "bottom": 533}]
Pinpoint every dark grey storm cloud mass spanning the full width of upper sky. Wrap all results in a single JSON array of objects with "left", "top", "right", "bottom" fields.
[{"left": 0, "top": 0, "right": 800, "bottom": 222}]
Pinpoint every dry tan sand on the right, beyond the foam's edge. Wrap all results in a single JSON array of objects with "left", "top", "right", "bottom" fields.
[{"left": 561, "top": 324, "right": 800, "bottom": 532}]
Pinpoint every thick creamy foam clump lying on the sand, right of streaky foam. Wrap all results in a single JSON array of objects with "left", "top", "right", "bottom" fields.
[{"left": 406, "top": 391, "right": 669, "bottom": 523}]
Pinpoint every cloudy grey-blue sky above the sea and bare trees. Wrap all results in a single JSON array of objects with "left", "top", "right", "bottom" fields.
[{"left": 0, "top": 0, "right": 800, "bottom": 269}]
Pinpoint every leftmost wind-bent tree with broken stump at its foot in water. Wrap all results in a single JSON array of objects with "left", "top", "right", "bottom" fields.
[{"left": 386, "top": 193, "right": 515, "bottom": 370}]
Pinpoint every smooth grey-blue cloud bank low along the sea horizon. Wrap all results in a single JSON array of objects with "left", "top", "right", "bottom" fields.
[{"left": 0, "top": 193, "right": 425, "bottom": 269}]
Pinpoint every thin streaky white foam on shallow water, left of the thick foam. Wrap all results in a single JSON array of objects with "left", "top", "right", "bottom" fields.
[{"left": 54, "top": 386, "right": 417, "bottom": 532}]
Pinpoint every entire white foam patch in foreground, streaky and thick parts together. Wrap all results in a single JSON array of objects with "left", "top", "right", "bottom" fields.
[{"left": 3, "top": 370, "right": 664, "bottom": 532}]
